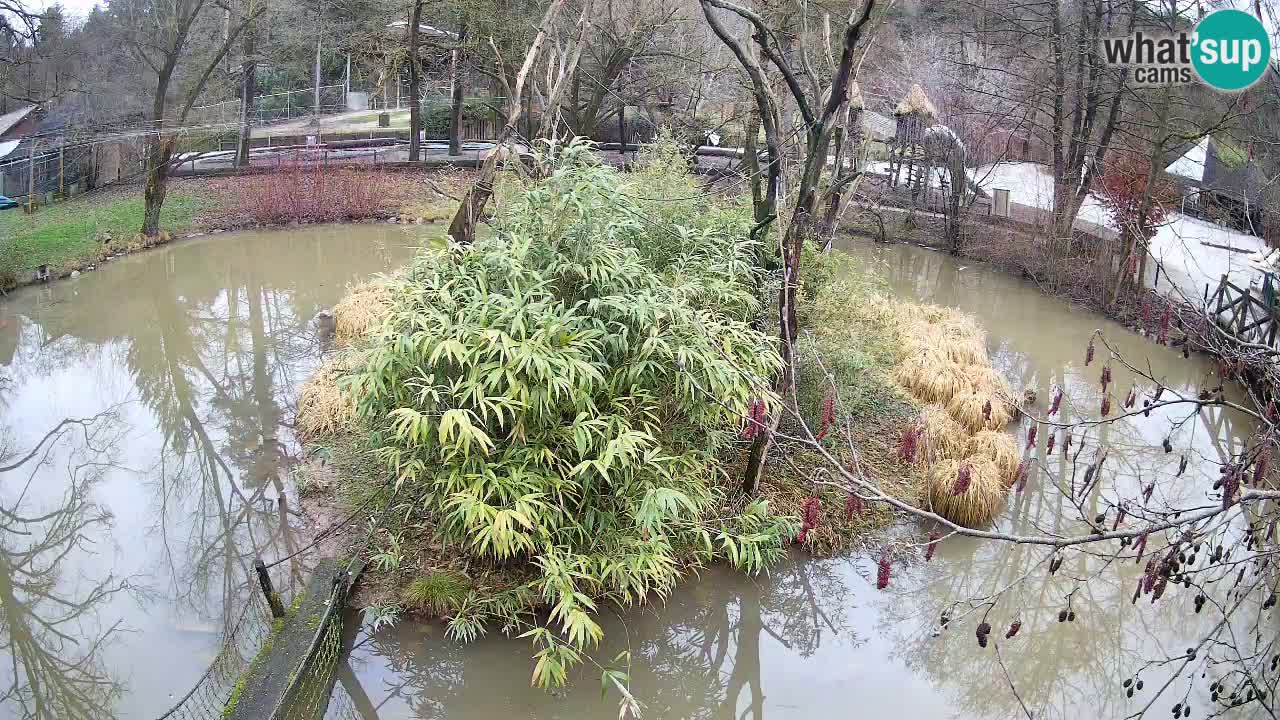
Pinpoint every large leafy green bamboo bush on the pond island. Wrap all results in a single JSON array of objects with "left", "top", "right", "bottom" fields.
[{"left": 344, "top": 142, "right": 794, "bottom": 687}]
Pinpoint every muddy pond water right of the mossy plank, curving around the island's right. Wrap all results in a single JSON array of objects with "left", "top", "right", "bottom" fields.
[{"left": 342, "top": 238, "right": 1252, "bottom": 720}]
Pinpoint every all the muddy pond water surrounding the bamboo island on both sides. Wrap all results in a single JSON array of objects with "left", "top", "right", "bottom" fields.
[{"left": 0, "top": 225, "right": 1249, "bottom": 720}]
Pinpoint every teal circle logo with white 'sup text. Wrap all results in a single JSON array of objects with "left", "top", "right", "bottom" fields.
[{"left": 1192, "top": 10, "right": 1271, "bottom": 92}]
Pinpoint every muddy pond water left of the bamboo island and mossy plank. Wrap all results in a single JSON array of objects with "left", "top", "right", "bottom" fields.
[{"left": 0, "top": 225, "right": 425, "bottom": 720}]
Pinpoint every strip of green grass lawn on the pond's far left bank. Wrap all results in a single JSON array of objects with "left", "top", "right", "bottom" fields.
[{"left": 0, "top": 190, "right": 202, "bottom": 286}]
